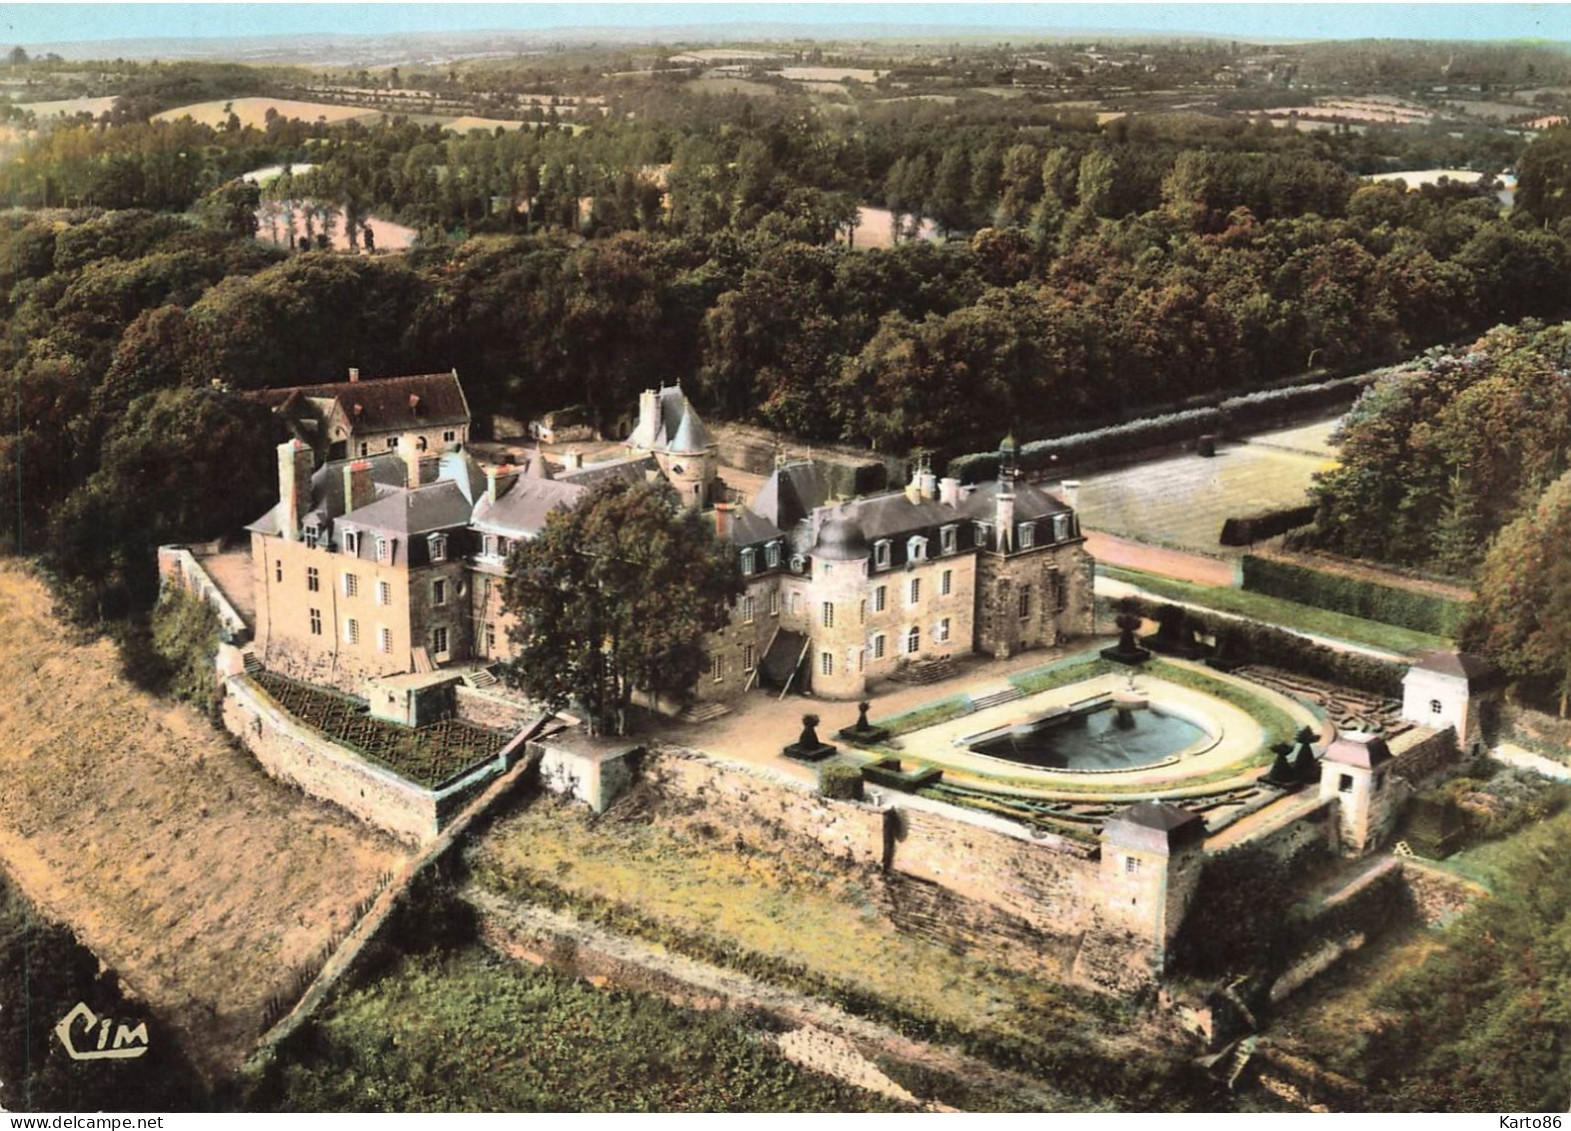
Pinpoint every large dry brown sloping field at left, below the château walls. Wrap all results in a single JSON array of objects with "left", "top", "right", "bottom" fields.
[{"left": 0, "top": 561, "right": 408, "bottom": 1079}]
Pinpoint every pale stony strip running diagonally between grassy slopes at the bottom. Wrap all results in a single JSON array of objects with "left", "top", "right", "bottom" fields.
[{"left": 463, "top": 884, "right": 1084, "bottom": 1111}]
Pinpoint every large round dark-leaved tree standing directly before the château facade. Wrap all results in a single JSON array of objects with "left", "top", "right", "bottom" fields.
[{"left": 503, "top": 481, "right": 742, "bottom": 734}]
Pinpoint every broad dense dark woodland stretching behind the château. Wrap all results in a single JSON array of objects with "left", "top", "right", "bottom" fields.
[{"left": 0, "top": 53, "right": 1571, "bottom": 620}]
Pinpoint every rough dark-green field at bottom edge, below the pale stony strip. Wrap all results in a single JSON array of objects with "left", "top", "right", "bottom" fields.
[{"left": 259, "top": 947, "right": 900, "bottom": 1112}]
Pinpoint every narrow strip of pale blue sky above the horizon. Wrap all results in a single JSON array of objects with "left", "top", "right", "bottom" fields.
[{"left": 0, "top": 0, "right": 1571, "bottom": 46}]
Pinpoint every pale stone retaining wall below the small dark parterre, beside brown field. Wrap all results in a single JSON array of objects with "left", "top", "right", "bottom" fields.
[{"left": 223, "top": 677, "right": 438, "bottom": 844}]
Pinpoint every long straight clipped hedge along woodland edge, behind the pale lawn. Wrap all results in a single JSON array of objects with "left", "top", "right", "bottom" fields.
[{"left": 947, "top": 372, "right": 1379, "bottom": 482}]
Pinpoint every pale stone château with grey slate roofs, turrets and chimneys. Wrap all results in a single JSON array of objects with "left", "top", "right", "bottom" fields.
[{"left": 238, "top": 375, "right": 1092, "bottom": 699}]
